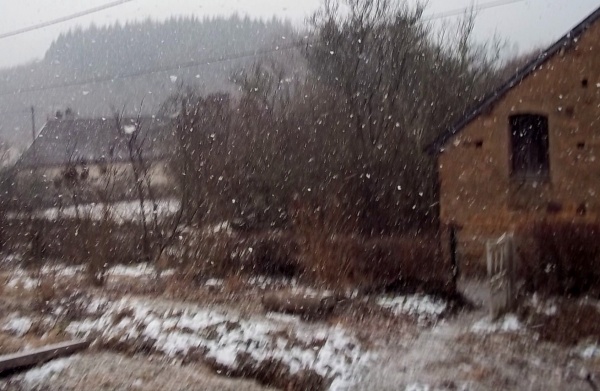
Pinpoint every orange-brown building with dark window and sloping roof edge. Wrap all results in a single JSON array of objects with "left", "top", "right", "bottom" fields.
[{"left": 427, "top": 8, "right": 600, "bottom": 274}]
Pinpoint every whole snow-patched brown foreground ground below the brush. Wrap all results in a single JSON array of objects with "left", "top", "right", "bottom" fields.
[{"left": 0, "top": 265, "right": 600, "bottom": 391}]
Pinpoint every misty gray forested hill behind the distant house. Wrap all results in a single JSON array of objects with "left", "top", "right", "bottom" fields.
[{"left": 0, "top": 16, "right": 295, "bottom": 149}]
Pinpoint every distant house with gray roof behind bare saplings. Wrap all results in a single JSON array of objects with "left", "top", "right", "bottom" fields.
[{"left": 15, "top": 117, "right": 173, "bottom": 203}]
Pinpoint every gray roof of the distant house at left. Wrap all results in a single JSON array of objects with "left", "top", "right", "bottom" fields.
[{"left": 17, "top": 117, "right": 172, "bottom": 168}]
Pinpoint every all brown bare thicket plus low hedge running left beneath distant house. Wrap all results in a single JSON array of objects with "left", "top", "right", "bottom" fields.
[{"left": 0, "top": 0, "right": 506, "bottom": 291}]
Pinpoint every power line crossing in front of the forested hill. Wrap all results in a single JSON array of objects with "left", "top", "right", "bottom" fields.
[{"left": 0, "top": 42, "right": 307, "bottom": 96}]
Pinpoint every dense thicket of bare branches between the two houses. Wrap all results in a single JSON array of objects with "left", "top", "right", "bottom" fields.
[{"left": 169, "top": 0, "right": 496, "bottom": 236}]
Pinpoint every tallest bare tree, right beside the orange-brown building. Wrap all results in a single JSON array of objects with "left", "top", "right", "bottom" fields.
[{"left": 305, "top": 0, "right": 502, "bottom": 234}]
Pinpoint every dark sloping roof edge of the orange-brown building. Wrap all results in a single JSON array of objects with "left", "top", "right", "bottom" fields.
[{"left": 425, "top": 7, "right": 600, "bottom": 155}]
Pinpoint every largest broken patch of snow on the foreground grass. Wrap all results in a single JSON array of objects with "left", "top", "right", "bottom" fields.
[{"left": 65, "top": 299, "right": 372, "bottom": 390}]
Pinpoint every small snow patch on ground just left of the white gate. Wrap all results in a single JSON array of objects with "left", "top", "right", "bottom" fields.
[{"left": 377, "top": 295, "right": 448, "bottom": 322}]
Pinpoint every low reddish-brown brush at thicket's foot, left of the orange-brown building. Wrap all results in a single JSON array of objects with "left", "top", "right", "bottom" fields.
[{"left": 303, "top": 235, "right": 452, "bottom": 293}]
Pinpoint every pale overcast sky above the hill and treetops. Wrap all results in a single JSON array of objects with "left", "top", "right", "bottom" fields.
[{"left": 0, "top": 0, "right": 600, "bottom": 67}]
